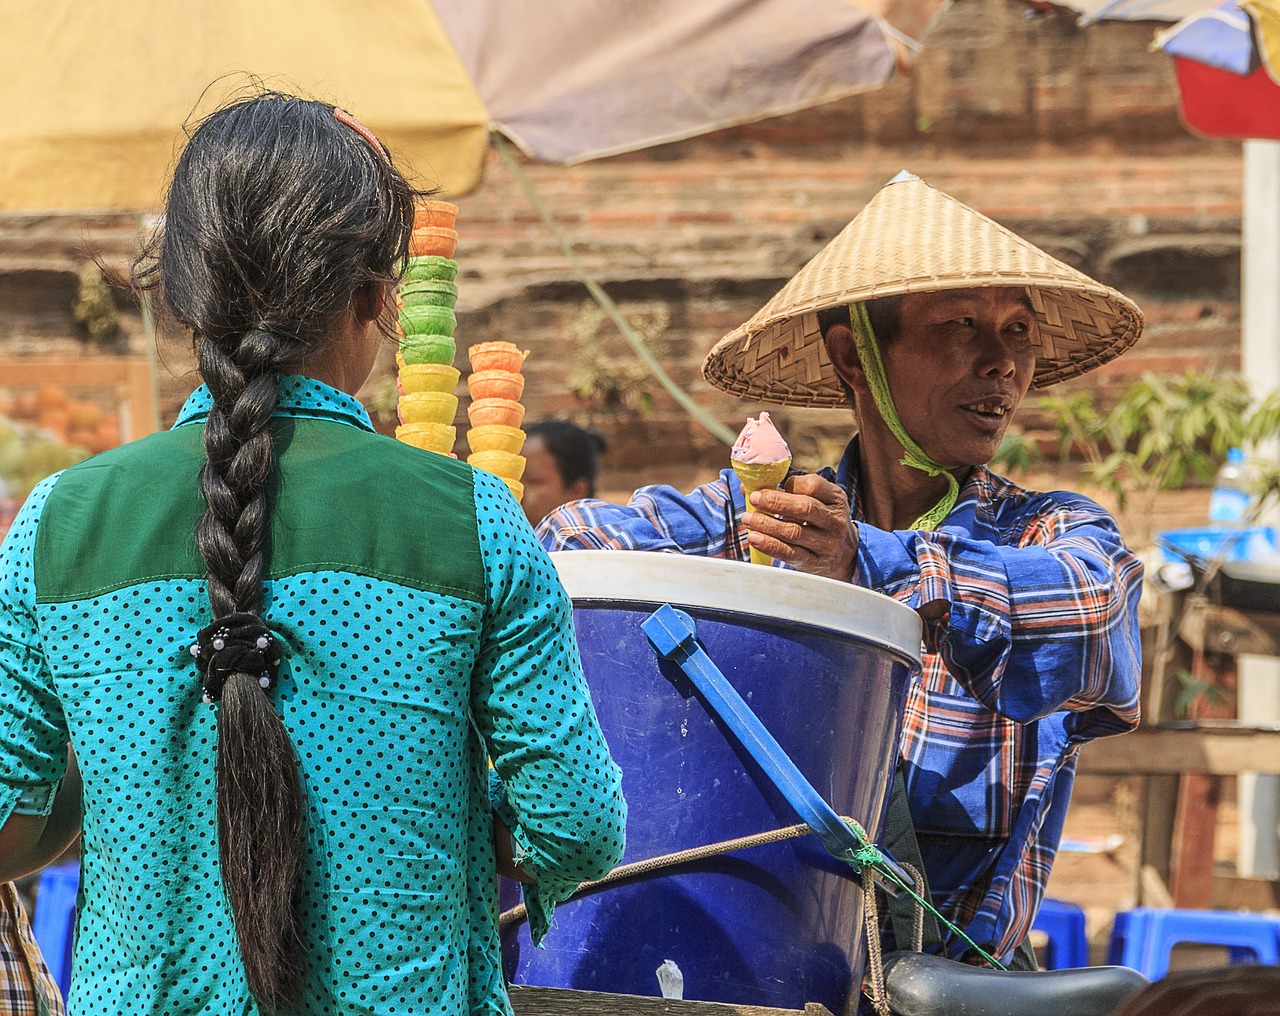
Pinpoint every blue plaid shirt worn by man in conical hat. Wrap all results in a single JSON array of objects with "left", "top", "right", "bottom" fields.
[{"left": 538, "top": 440, "right": 1142, "bottom": 957}]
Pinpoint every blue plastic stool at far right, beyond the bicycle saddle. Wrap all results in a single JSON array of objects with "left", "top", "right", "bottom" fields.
[{"left": 1107, "top": 907, "right": 1280, "bottom": 980}]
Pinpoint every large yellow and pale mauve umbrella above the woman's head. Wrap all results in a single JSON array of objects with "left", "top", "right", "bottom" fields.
[{"left": 0, "top": 0, "right": 942, "bottom": 211}]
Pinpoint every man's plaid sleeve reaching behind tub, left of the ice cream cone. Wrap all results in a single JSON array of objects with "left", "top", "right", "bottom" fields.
[{"left": 538, "top": 470, "right": 745, "bottom": 558}]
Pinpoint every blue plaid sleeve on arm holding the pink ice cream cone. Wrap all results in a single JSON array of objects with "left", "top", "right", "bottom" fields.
[{"left": 855, "top": 495, "right": 1142, "bottom": 740}]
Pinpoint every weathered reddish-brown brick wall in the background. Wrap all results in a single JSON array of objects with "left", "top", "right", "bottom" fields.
[{"left": 0, "top": 0, "right": 1240, "bottom": 506}]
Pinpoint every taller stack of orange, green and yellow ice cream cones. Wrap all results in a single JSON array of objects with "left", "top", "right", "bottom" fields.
[{"left": 396, "top": 201, "right": 461, "bottom": 454}]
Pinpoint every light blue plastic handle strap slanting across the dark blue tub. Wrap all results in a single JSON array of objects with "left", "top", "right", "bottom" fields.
[{"left": 640, "top": 603, "right": 913, "bottom": 885}]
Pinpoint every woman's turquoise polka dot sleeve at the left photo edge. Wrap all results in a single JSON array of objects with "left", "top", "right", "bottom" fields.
[{"left": 0, "top": 473, "right": 67, "bottom": 825}]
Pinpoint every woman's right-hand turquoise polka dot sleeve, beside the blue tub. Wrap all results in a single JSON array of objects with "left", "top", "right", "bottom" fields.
[{"left": 471, "top": 470, "right": 626, "bottom": 943}]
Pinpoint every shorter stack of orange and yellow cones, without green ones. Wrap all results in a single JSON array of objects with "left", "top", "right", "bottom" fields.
[{"left": 467, "top": 342, "right": 529, "bottom": 500}]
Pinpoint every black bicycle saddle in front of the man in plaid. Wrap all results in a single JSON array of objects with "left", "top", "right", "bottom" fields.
[{"left": 884, "top": 952, "right": 1148, "bottom": 1016}]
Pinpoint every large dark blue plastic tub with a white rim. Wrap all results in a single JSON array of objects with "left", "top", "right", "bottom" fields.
[{"left": 503, "top": 552, "right": 920, "bottom": 1012}]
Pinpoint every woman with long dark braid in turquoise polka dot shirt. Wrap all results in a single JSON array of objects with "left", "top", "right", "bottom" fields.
[{"left": 0, "top": 93, "right": 625, "bottom": 1016}]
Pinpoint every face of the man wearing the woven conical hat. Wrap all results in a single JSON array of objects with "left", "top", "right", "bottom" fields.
[{"left": 881, "top": 288, "right": 1037, "bottom": 467}]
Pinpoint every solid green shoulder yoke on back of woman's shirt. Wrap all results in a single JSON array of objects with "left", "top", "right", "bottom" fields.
[{"left": 36, "top": 416, "right": 485, "bottom": 603}]
